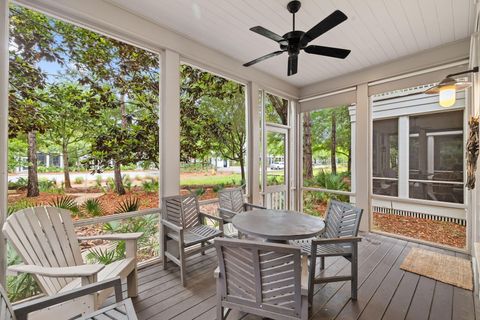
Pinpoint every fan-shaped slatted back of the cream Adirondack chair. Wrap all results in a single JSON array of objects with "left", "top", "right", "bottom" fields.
[{"left": 3, "top": 207, "right": 84, "bottom": 295}]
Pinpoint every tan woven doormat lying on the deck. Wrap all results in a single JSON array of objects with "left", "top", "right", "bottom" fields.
[{"left": 400, "top": 248, "right": 473, "bottom": 290}]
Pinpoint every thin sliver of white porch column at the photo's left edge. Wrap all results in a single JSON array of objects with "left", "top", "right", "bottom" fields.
[{"left": 0, "top": 0, "right": 9, "bottom": 287}]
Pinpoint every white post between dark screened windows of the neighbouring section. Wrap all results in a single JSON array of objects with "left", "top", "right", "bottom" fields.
[{"left": 398, "top": 116, "right": 408, "bottom": 199}]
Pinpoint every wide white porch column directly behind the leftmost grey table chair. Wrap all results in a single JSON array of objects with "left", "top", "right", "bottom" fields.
[{"left": 160, "top": 50, "right": 180, "bottom": 197}]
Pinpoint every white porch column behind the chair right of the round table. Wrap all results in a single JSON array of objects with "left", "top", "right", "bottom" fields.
[{"left": 354, "top": 83, "right": 371, "bottom": 231}]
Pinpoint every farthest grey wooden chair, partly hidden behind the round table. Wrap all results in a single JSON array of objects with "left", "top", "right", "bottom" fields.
[{"left": 218, "top": 187, "right": 266, "bottom": 237}]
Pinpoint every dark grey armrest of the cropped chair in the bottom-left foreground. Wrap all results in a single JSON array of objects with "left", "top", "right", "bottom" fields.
[{"left": 13, "top": 277, "right": 123, "bottom": 320}]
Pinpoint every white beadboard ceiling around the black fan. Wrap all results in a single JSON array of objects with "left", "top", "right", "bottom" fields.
[{"left": 108, "top": 0, "right": 474, "bottom": 87}]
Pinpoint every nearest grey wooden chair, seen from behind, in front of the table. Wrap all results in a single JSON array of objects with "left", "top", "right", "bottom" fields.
[{"left": 214, "top": 238, "right": 308, "bottom": 320}]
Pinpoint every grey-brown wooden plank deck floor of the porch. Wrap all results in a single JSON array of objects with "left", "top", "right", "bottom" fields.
[{"left": 123, "top": 234, "right": 480, "bottom": 320}]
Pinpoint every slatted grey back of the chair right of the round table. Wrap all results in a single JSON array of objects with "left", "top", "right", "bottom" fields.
[{"left": 323, "top": 200, "right": 363, "bottom": 238}]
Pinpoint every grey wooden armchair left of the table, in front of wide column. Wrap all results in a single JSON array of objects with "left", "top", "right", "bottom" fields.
[{"left": 161, "top": 194, "right": 223, "bottom": 287}]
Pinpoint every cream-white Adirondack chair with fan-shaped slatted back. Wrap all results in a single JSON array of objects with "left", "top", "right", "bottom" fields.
[{"left": 3, "top": 207, "right": 142, "bottom": 319}]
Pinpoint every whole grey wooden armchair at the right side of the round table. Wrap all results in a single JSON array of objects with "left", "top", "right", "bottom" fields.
[{"left": 291, "top": 200, "right": 363, "bottom": 306}]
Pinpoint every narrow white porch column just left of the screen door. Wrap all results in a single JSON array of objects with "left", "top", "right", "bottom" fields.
[{"left": 247, "top": 82, "right": 262, "bottom": 204}]
